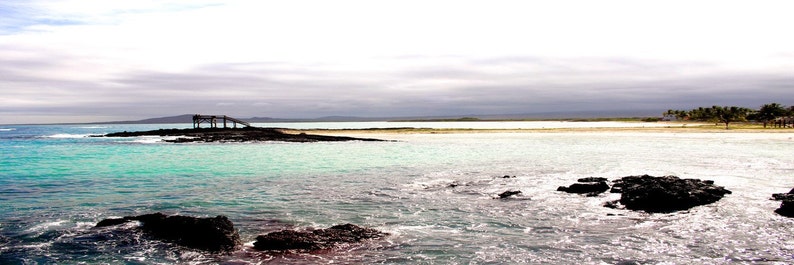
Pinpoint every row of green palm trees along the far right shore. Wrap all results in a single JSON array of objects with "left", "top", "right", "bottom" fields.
[{"left": 664, "top": 103, "right": 794, "bottom": 129}]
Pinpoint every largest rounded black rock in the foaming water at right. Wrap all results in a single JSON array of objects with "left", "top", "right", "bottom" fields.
[{"left": 612, "top": 175, "right": 731, "bottom": 213}]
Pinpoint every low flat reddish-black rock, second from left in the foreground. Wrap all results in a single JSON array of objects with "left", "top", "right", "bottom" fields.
[{"left": 254, "top": 224, "right": 388, "bottom": 251}]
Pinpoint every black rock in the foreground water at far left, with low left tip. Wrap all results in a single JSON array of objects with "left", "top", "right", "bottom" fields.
[{"left": 96, "top": 213, "right": 240, "bottom": 251}]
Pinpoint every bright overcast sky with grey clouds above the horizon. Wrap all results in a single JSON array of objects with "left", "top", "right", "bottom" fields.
[{"left": 0, "top": 0, "right": 794, "bottom": 124}]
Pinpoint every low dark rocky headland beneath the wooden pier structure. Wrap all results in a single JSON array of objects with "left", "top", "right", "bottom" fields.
[{"left": 104, "top": 127, "right": 383, "bottom": 143}]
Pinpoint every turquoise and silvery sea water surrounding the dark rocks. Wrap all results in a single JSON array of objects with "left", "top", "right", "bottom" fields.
[{"left": 0, "top": 122, "right": 794, "bottom": 264}]
